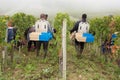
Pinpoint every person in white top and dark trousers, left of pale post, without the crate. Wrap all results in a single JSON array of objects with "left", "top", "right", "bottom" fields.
[{"left": 35, "top": 14, "right": 52, "bottom": 58}]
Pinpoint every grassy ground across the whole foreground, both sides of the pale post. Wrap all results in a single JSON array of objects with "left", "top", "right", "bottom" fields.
[{"left": 0, "top": 41, "right": 120, "bottom": 80}]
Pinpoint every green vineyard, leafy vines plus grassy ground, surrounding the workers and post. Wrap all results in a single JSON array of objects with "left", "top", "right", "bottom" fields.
[{"left": 0, "top": 13, "right": 120, "bottom": 80}]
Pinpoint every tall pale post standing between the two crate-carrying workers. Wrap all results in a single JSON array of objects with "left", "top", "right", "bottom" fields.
[{"left": 62, "top": 19, "right": 67, "bottom": 80}]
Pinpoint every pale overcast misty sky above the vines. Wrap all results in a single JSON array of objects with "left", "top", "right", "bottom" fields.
[{"left": 0, "top": 0, "right": 120, "bottom": 16}]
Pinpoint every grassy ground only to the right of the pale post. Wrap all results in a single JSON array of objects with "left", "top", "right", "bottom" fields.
[{"left": 67, "top": 42, "right": 120, "bottom": 80}]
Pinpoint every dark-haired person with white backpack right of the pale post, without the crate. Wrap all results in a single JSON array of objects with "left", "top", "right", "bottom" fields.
[{"left": 70, "top": 14, "right": 89, "bottom": 57}]
